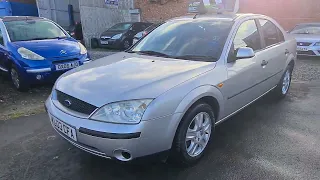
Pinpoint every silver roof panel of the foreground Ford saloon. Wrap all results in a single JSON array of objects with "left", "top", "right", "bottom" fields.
[{"left": 171, "top": 13, "right": 263, "bottom": 21}]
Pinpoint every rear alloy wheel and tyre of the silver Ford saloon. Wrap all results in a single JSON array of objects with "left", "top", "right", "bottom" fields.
[{"left": 273, "top": 65, "right": 293, "bottom": 99}]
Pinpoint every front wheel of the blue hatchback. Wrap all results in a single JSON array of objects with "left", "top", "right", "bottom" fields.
[{"left": 9, "top": 65, "right": 29, "bottom": 92}]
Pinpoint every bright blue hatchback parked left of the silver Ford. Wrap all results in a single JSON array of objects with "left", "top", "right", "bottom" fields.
[{"left": 0, "top": 16, "right": 90, "bottom": 91}]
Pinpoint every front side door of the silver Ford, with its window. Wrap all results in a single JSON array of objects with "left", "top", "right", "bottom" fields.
[{"left": 222, "top": 19, "right": 264, "bottom": 117}]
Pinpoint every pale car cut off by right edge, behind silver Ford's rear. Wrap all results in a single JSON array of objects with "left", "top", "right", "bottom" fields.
[{"left": 290, "top": 23, "right": 320, "bottom": 56}]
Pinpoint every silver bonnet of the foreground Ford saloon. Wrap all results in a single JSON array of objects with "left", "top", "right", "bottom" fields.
[{"left": 55, "top": 53, "right": 216, "bottom": 107}]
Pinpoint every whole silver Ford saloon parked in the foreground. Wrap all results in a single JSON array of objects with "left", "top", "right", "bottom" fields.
[{"left": 46, "top": 14, "right": 297, "bottom": 164}]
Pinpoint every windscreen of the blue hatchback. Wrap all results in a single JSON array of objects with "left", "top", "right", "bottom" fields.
[{"left": 4, "top": 20, "right": 67, "bottom": 42}]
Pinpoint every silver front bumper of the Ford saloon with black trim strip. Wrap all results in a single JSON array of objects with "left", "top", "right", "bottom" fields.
[{"left": 46, "top": 98, "right": 181, "bottom": 161}]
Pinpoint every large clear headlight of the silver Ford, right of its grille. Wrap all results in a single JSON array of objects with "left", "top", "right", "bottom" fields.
[{"left": 90, "top": 99, "right": 152, "bottom": 124}]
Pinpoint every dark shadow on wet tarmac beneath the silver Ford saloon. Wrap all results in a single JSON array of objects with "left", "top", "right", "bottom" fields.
[{"left": 63, "top": 91, "right": 283, "bottom": 179}]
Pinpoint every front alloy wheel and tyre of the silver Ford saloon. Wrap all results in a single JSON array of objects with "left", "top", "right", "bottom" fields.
[{"left": 169, "top": 102, "right": 215, "bottom": 166}]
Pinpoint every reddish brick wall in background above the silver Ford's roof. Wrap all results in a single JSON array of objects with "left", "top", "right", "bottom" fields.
[{"left": 135, "top": 0, "right": 320, "bottom": 30}]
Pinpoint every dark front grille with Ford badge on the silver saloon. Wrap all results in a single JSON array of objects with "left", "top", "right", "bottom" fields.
[{"left": 57, "top": 90, "right": 97, "bottom": 115}]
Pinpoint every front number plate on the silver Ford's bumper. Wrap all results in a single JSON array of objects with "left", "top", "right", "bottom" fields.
[{"left": 51, "top": 117, "right": 77, "bottom": 141}]
